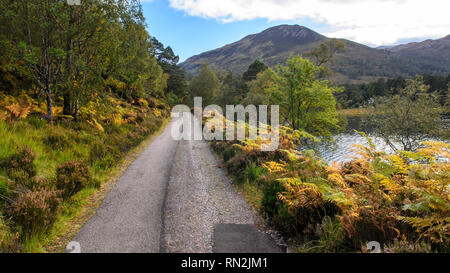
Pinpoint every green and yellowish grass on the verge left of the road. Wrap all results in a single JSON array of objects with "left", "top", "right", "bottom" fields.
[{"left": 0, "top": 112, "right": 168, "bottom": 253}]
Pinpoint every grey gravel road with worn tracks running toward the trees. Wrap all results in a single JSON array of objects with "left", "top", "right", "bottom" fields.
[{"left": 72, "top": 113, "right": 280, "bottom": 253}]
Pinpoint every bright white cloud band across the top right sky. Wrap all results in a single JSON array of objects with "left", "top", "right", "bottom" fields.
[{"left": 165, "top": 0, "right": 450, "bottom": 45}]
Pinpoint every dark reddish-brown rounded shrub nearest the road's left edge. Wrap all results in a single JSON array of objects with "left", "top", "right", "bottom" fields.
[{"left": 56, "top": 160, "right": 91, "bottom": 199}]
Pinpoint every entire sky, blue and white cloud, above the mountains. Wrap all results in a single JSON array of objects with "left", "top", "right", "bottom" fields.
[{"left": 141, "top": 0, "right": 450, "bottom": 62}]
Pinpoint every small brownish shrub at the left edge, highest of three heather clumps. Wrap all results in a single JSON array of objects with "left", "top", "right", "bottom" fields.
[{"left": 0, "top": 146, "right": 36, "bottom": 182}]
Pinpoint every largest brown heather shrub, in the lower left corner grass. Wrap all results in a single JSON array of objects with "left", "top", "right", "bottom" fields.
[{"left": 8, "top": 189, "right": 61, "bottom": 235}]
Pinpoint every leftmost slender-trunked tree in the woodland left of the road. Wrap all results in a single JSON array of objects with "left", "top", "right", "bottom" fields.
[{"left": 14, "top": 1, "right": 66, "bottom": 119}]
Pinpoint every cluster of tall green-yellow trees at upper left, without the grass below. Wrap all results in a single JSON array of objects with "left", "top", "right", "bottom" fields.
[{"left": 0, "top": 0, "right": 169, "bottom": 119}]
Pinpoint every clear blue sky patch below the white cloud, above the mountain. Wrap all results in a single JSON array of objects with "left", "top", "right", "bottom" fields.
[{"left": 142, "top": 0, "right": 328, "bottom": 62}]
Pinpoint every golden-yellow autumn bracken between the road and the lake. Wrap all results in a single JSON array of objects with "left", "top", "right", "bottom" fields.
[{"left": 212, "top": 116, "right": 450, "bottom": 252}]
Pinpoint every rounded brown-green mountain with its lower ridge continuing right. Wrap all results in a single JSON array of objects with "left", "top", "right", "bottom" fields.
[{"left": 180, "top": 25, "right": 450, "bottom": 83}]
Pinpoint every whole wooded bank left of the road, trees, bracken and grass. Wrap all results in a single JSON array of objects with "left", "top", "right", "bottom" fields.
[{"left": 0, "top": 0, "right": 179, "bottom": 252}]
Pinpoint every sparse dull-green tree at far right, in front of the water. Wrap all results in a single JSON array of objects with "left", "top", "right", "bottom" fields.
[{"left": 366, "top": 76, "right": 448, "bottom": 151}]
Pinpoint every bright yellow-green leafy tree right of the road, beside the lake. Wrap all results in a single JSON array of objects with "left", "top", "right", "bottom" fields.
[{"left": 266, "top": 55, "right": 340, "bottom": 137}]
